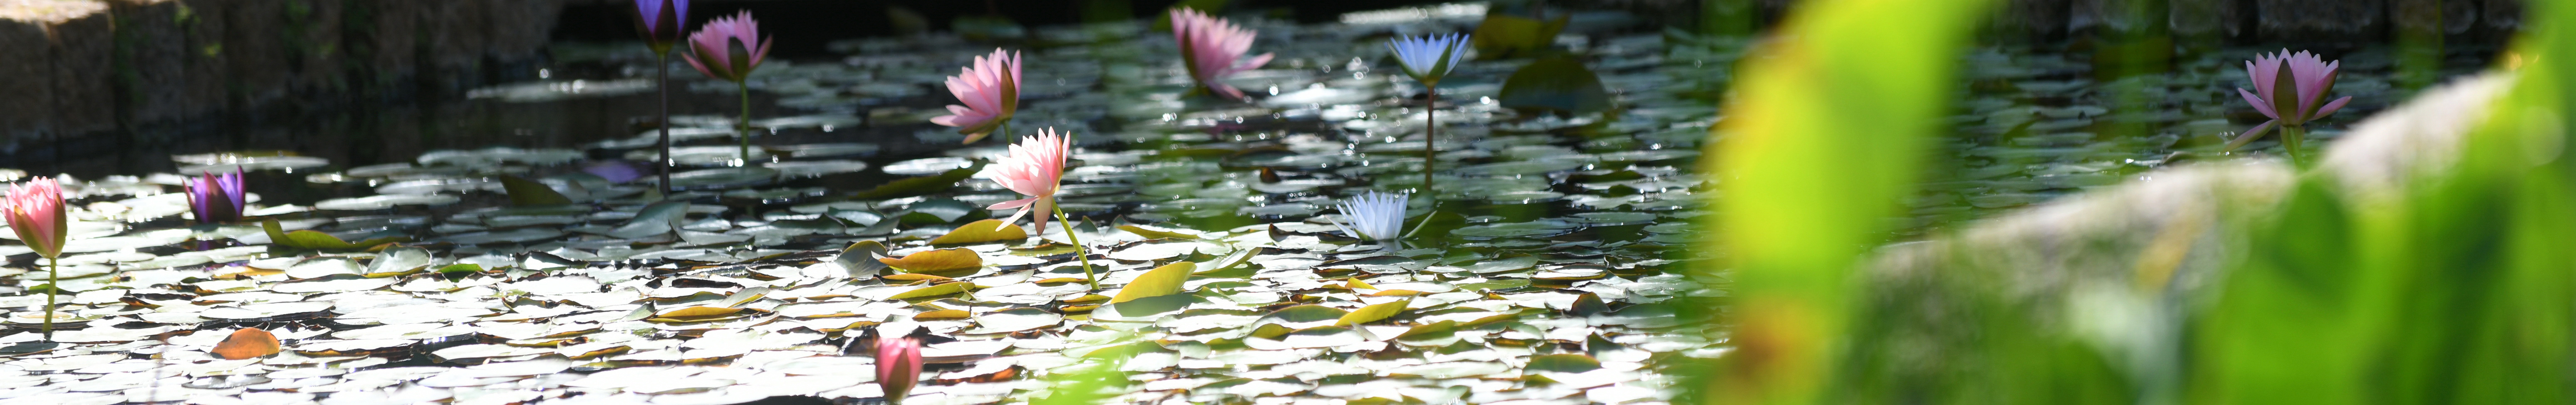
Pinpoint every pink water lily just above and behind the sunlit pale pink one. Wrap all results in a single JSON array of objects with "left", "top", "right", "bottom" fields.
[{"left": 930, "top": 49, "right": 1020, "bottom": 144}]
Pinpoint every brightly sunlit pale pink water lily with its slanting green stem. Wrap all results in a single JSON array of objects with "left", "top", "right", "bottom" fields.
[{"left": 984, "top": 129, "right": 1100, "bottom": 289}]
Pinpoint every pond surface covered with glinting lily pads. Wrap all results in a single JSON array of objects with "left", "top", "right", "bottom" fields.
[{"left": 0, "top": 4, "right": 2483, "bottom": 405}]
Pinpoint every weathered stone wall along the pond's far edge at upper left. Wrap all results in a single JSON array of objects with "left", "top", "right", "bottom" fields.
[{"left": 0, "top": 0, "right": 564, "bottom": 152}]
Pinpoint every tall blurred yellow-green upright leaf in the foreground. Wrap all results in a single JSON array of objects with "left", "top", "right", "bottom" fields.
[{"left": 1689, "top": 0, "right": 1981, "bottom": 403}]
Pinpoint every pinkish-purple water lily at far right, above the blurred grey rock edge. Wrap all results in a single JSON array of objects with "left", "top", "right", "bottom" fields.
[{"left": 2228, "top": 49, "right": 2352, "bottom": 160}]
